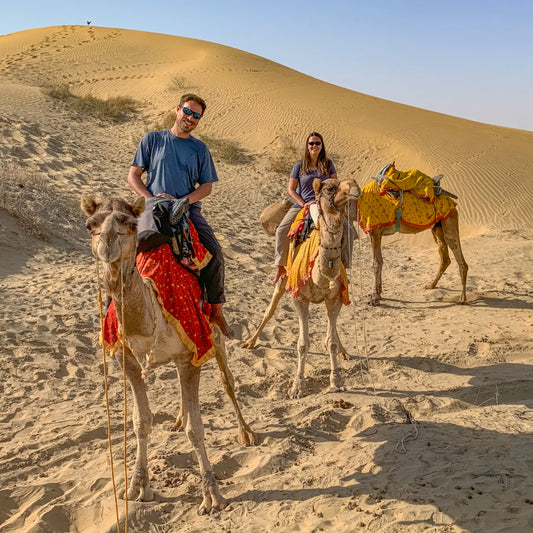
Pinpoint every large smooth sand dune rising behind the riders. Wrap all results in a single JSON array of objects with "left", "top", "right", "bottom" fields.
[{"left": 0, "top": 26, "right": 533, "bottom": 229}]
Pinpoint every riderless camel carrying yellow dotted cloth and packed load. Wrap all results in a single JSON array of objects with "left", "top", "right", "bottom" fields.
[{"left": 358, "top": 163, "right": 468, "bottom": 306}]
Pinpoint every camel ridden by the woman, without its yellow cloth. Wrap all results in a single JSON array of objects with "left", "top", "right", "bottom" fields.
[{"left": 242, "top": 179, "right": 361, "bottom": 399}]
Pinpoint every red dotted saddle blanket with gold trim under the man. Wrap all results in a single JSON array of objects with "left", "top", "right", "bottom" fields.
[{"left": 102, "top": 225, "right": 215, "bottom": 366}]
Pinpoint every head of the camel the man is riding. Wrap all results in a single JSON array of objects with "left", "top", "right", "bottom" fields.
[{"left": 81, "top": 195, "right": 144, "bottom": 263}]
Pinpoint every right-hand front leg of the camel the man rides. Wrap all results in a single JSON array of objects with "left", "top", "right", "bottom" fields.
[{"left": 176, "top": 361, "right": 226, "bottom": 515}]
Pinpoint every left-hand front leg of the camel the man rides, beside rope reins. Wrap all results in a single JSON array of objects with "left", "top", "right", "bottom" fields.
[{"left": 115, "top": 347, "right": 154, "bottom": 502}]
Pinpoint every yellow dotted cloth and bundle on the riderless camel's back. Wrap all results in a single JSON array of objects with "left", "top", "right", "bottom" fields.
[{"left": 357, "top": 165, "right": 456, "bottom": 233}]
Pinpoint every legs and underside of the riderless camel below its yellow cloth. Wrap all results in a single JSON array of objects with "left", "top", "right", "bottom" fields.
[{"left": 360, "top": 179, "right": 468, "bottom": 306}]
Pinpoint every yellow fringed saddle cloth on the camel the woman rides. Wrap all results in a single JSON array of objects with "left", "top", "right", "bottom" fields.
[{"left": 286, "top": 212, "right": 350, "bottom": 305}]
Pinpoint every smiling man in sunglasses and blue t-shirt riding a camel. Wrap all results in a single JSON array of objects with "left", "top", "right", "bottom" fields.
[{"left": 128, "top": 94, "right": 233, "bottom": 338}]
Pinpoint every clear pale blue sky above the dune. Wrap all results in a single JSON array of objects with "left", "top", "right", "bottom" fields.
[{"left": 0, "top": 0, "right": 533, "bottom": 131}]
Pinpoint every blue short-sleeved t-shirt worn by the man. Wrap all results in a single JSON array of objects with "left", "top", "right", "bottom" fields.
[{"left": 131, "top": 130, "right": 218, "bottom": 205}]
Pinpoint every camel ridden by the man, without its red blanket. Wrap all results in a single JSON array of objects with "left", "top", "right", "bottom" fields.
[{"left": 81, "top": 195, "right": 258, "bottom": 514}]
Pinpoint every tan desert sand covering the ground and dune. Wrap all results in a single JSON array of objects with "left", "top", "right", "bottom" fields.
[{"left": 0, "top": 26, "right": 533, "bottom": 533}]
